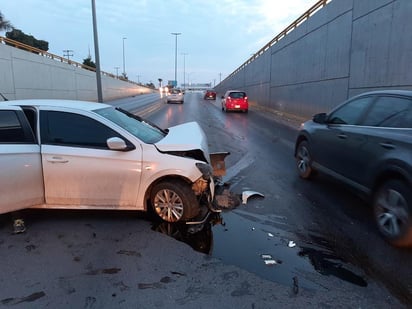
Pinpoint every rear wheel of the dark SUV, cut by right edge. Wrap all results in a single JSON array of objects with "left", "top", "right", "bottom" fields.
[{"left": 373, "top": 179, "right": 412, "bottom": 247}]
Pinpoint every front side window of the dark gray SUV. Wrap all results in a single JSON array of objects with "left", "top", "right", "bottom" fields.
[{"left": 328, "top": 97, "right": 372, "bottom": 125}]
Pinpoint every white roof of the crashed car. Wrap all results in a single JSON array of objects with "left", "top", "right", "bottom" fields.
[{"left": 0, "top": 99, "right": 111, "bottom": 111}]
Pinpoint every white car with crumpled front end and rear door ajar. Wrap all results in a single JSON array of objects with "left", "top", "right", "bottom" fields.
[{"left": 0, "top": 100, "right": 224, "bottom": 222}]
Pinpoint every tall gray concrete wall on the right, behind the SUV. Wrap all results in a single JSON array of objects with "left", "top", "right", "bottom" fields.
[{"left": 216, "top": 0, "right": 412, "bottom": 118}]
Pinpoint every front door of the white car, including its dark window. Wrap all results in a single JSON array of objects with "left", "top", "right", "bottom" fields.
[{"left": 40, "top": 110, "right": 142, "bottom": 209}]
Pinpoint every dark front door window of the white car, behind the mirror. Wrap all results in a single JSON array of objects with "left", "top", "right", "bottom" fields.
[{"left": 40, "top": 111, "right": 125, "bottom": 149}]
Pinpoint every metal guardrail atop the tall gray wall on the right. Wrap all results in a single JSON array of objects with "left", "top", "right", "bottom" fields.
[{"left": 225, "top": 0, "right": 332, "bottom": 79}]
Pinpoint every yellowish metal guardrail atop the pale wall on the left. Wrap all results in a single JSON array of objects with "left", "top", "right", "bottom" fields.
[{"left": 0, "top": 36, "right": 134, "bottom": 82}]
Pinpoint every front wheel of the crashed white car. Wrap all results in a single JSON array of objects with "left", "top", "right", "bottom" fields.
[{"left": 150, "top": 180, "right": 200, "bottom": 222}]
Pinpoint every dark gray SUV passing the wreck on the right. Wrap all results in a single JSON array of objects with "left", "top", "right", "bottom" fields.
[{"left": 295, "top": 90, "right": 412, "bottom": 246}]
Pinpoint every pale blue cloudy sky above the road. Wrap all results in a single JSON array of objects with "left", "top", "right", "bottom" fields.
[{"left": 0, "top": 0, "right": 317, "bottom": 86}]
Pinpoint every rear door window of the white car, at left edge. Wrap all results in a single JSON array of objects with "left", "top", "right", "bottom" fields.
[{"left": 0, "top": 110, "right": 34, "bottom": 144}]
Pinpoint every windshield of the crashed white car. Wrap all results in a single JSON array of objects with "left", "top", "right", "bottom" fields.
[{"left": 95, "top": 107, "right": 167, "bottom": 144}]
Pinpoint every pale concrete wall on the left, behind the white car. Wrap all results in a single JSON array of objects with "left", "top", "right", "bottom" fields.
[{"left": 0, "top": 44, "right": 152, "bottom": 101}]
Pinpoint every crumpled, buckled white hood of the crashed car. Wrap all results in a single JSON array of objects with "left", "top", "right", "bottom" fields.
[{"left": 155, "top": 122, "right": 210, "bottom": 163}]
